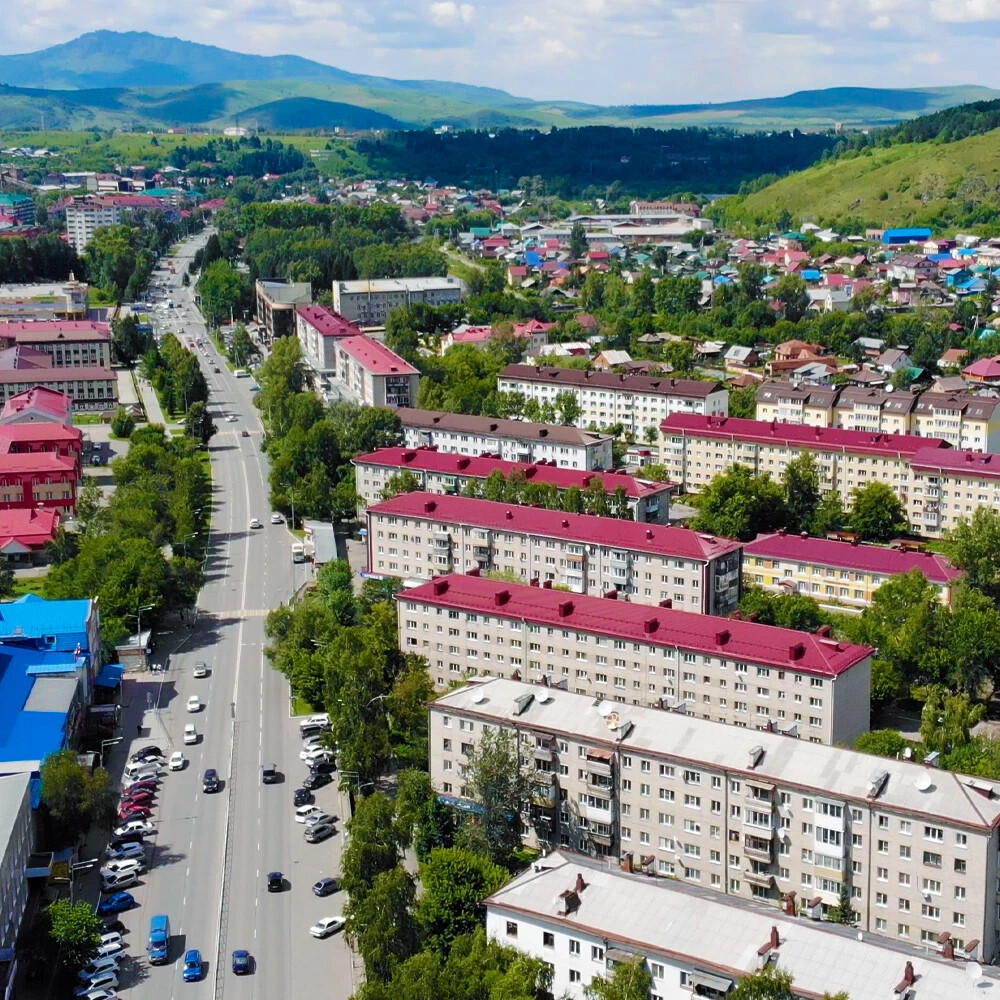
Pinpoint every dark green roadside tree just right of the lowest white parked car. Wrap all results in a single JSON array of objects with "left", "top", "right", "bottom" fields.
[{"left": 344, "top": 865, "right": 418, "bottom": 982}]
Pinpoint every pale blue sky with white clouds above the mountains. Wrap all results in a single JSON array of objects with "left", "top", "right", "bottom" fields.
[{"left": 0, "top": 0, "right": 1000, "bottom": 104}]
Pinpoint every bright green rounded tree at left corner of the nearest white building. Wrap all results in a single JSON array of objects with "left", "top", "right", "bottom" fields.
[{"left": 417, "top": 847, "right": 510, "bottom": 955}]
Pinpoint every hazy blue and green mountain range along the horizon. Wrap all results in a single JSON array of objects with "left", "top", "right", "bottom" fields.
[{"left": 0, "top": 31, "right": 1000, "bottom": 131}]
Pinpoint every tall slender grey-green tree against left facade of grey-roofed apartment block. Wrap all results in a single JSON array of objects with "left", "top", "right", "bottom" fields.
[{"left": 463, "top": 728, "right": 532, "bottom": 865}]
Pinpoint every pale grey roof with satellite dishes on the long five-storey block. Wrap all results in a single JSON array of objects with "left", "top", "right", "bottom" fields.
[{"left": 438, "top": 680, "right": 1000, "bottom": 828}]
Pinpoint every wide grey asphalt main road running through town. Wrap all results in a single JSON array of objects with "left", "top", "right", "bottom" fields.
[{"left": 108, "top": 237, "right": 356, "bottom": 1000}]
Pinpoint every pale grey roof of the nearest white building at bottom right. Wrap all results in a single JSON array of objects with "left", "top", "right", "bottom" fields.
[{"left": 485, "top": 850, "right": 1000, "bottom": 1000}]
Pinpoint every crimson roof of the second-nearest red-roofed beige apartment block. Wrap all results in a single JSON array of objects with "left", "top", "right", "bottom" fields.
[{"left": 368, "top": 493, "right": 741, "bottom": 562}]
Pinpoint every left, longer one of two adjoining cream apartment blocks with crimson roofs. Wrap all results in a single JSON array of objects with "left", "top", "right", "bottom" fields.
[{"left": 660, "top": 413, "right": 949, "bottom": 508}]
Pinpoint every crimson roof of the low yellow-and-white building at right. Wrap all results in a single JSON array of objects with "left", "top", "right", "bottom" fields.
[{"left": 743, "top": 531, "right": 962, "bottom": 583}]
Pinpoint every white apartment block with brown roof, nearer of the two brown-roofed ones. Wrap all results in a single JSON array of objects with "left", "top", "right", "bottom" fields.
[{"left": 399, "top": 409, "right": 614, "bottom": 471}]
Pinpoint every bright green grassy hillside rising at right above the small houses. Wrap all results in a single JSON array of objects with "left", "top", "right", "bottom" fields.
[{"left": 713, "top": 129, "right": 1000, "bottom": 231}]
